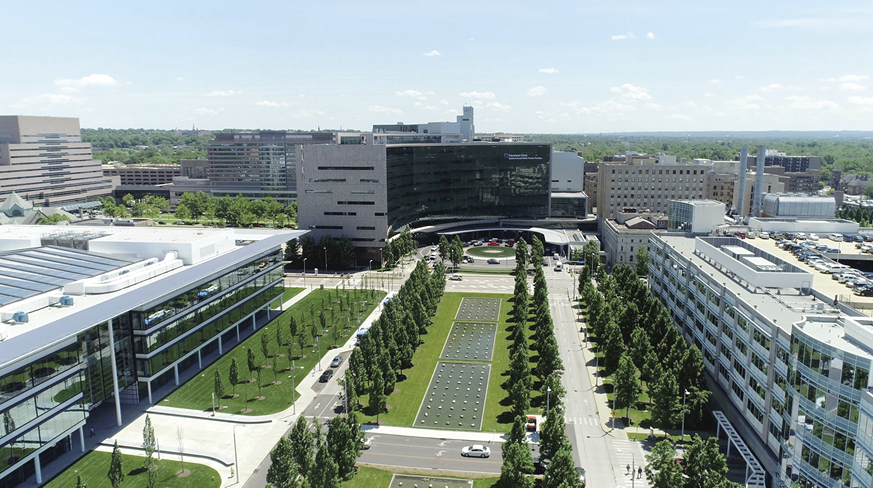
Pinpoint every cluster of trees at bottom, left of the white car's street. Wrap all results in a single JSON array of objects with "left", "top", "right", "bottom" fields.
[{"left": 267, "top": 411, "right": 364, "bottom": 488}]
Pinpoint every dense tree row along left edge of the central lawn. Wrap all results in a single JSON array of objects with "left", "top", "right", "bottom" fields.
[{"left": 344, "top": 261, "right": 446, "bottom": 423}]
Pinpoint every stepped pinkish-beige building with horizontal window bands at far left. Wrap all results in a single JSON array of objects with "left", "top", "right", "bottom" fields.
[{"left": 0, "top": 115, "right": 112, "bottom": 207}]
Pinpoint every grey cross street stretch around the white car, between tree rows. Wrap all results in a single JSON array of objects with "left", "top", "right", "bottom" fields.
[{"left": 358, "top": 434, "right": 503, "bottom": 473}]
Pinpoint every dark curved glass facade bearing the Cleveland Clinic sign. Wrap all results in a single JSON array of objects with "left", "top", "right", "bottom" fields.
[{"left": 387, "top": 144, "right": 551, "bottom": 231}]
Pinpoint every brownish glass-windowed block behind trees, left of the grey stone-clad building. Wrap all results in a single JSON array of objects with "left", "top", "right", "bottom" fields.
[{"left": 206, "top": 131, "right": 336, "bottom": 205}]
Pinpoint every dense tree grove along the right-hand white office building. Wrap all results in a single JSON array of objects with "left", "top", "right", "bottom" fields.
[{"left": 580, "top": 260, "right": 710, "bottom": 428}]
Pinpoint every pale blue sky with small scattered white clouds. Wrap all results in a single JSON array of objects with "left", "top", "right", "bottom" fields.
[{"left": 0, "top": 0, "right": 873, "bottom": 133}]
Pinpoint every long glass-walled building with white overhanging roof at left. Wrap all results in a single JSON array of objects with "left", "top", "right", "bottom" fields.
[{"left": 0, "top": 226, "right": 304, "bottom": 487}]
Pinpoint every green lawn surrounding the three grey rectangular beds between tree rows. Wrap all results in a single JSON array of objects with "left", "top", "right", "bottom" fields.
[{"left": 360, "top": 293, "right": 541, "bottom": 432}]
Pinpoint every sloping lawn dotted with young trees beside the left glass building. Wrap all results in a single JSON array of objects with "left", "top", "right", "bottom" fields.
[{"left": 160, "top": 289, "right": 385, "bottom": 415}]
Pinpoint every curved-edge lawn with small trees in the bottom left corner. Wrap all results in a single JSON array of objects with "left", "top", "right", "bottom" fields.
[{"left": 44, "top": 451, "right": 221, "bottom": 488}]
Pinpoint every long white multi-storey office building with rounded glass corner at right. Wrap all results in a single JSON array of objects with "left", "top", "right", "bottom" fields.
[{"left": 649, "top": 234, "right": 873, "bottom": 488}]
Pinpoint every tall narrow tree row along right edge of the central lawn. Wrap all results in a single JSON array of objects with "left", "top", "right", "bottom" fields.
[{"left": 500, "top": 237, "right": 579, "bottom": 488}]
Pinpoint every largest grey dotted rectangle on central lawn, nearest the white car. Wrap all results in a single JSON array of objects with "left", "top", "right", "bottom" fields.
[{"left": 415, "top": 361, "right": 491, "bottom": 431}]
